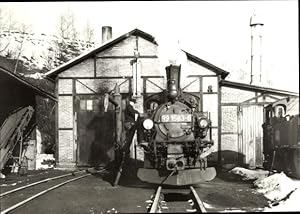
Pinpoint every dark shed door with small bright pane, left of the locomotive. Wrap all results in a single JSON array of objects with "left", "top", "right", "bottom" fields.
[{"left": 75, "top": 95, "right": 114, "bottom": 166}]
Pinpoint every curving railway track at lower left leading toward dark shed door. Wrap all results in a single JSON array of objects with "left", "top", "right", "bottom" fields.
[{"left": 0, "top": 169, "right": 105, "bottom": 214}]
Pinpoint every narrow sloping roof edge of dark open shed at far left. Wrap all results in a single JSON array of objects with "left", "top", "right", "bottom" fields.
[{"left": 0, "top": 66, "right": 57, "bottom": 101}]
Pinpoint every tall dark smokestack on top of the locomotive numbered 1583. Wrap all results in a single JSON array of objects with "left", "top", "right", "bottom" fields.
[{"left": 166, "top": 65, "right": 181, "bottom": 100}]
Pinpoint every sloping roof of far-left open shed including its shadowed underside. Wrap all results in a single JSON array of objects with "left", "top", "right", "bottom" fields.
[{"left": 0, "top": 66, "right": 57, "bottom": 101}]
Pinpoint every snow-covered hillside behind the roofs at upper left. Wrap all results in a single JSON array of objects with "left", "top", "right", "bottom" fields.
[{"left": 0, "top": 31, "right": 97, "bottom": 72}]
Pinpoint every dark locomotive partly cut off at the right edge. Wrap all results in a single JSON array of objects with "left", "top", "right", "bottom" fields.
[{"left": 262, "top": 98, "right": 300, "bottom": 178}]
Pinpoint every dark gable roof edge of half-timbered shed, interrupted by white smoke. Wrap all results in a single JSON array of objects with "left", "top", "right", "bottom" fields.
[{"left": 45, "top": 28, "right": 229, "bottom": 79}]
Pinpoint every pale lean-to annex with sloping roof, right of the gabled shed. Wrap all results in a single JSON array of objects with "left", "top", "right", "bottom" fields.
[{"left": 219, "top": 80, "right": 299, "bottom": 168}]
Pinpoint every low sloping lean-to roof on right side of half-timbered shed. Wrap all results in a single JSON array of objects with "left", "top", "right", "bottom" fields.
[{"left": 220, "top": 80, "right": 299, "bottom": 96}]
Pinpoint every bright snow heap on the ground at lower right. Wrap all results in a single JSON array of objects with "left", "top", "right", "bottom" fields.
[{"left": 230, "top": 167, "right": 300, "bottom": 212}]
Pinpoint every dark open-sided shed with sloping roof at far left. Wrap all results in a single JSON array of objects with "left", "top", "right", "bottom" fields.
[{"left": 0, "top": 62, "right": 56, "bottom": 170}]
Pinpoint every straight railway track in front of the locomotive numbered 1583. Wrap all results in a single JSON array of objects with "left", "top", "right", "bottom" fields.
[{"left": 148, "top": 186, "right": 207, "bottom": 213}]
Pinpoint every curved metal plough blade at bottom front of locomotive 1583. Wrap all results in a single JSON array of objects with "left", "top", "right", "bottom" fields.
[{"left": 138, "top": 167, "right": 217, "bottom": 186}]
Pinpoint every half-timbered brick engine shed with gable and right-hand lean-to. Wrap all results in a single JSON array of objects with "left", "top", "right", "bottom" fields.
[{"left": 46, "top": 29, "right": 298, "bottom": 170}]
